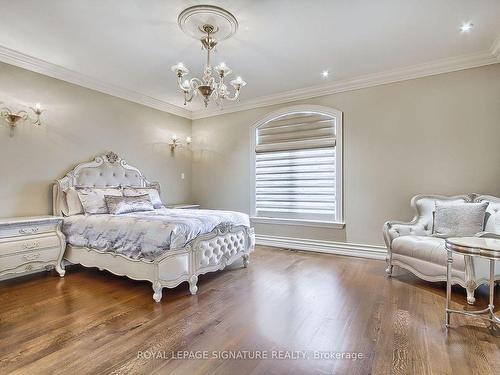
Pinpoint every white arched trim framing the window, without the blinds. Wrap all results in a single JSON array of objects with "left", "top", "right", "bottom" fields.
[{"left": 250, "top": 104, "right": 345, "bottom": 228}]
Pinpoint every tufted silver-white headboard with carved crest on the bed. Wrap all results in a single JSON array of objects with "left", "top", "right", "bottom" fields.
[{"left": 52, "top": 152, "right": 160, "bottom": 216}]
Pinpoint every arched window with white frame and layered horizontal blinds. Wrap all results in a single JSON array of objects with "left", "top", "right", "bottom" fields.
[{"left": 252, "top": 106, "right": 342, "bottom": 225}]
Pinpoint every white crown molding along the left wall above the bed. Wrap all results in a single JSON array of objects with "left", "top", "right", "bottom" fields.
[{"left": 0, "top": 46, "right": 191, "bottom": 119}]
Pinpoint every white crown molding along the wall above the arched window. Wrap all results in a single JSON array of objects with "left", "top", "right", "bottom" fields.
[{"left": 192, "top": 49, "right": 500, "bottom": 120}]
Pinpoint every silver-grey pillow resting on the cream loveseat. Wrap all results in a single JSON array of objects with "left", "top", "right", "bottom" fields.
[{"left": 433, "top": 202, "right": 488, "bottom": 238}]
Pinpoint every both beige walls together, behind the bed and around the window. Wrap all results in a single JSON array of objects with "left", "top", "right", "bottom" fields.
[{"left": 0, "top": 63, "right": 500, "bottom": 245}]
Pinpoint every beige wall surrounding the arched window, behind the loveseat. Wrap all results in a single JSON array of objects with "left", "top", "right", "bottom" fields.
[{"left": 193, "top": 64, "right": 500, "bottom": 245}]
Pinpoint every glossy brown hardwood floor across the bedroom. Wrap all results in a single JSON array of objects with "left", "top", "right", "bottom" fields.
[{"left": 0, "top": 247, "right": 500, "bottom": 375}]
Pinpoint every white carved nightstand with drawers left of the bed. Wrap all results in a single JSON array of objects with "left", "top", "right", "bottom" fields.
[{"left": 0, "top": 216, "right": 66, "bottom": 279}]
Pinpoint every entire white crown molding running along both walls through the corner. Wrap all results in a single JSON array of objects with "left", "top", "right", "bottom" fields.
[{"left": 0, "top": 35, "right": 500, "bottom": 120}]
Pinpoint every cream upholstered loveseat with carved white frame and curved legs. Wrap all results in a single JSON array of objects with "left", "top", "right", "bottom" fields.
[{"left": 383, "top": 194, "right": 500, "bottom": 304}]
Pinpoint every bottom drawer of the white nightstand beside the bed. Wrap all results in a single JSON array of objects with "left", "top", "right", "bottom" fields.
[{"left": 0, "top": 247, "right": 61, "bottom": 274}]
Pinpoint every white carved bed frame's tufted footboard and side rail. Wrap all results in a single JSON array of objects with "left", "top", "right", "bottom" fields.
[{"left": 64, "top": 224, "right": 255, "bottom": 302}]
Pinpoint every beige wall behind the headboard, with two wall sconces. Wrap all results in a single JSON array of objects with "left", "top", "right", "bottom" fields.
[{"left": 0, "top": 63, "right": 191, "bottom": 217}]
